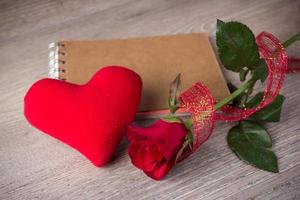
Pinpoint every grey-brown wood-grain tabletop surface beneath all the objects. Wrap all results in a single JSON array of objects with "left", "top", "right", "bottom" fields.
[{"left": 0, "top": 0, "right": 300, "bottom": 200}]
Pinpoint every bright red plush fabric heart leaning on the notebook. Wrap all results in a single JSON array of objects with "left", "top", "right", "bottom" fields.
[{"left": 24, "top": 66, "right": 142, "bottom": 166}]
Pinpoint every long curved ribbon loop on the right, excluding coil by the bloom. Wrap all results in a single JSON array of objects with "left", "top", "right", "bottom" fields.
[{"left": 216, "top": 32, "right": 288, "bottom": 121}]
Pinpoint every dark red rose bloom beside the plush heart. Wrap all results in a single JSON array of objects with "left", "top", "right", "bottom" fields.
[{"left": 127, "top": 119, "right": 187, "bottom": 180}]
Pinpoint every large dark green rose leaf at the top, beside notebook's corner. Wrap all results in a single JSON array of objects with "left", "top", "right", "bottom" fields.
[{"left": 216, "top": 20, "right": 259, "bottom": 72}]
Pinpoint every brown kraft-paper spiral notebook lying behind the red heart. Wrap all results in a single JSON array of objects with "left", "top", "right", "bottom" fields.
[{"left": 49, "top": 33, "right": 229, "bottom": 111}]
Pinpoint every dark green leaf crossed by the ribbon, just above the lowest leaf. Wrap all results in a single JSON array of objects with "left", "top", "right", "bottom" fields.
[{"left": 246, "top": 92, "right": 285, "bottom": 122}]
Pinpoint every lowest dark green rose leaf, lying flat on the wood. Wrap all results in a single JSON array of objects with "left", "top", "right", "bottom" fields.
[{"left": 227, "top": 121, "right": 278, "bottom": 173}]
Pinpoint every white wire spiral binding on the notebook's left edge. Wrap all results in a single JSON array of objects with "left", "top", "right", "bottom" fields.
[{"left": 48, "top": 42, "right": 66, "bottom": 80}]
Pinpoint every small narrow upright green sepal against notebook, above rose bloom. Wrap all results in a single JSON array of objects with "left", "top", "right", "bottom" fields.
[{"left": 168, "top": 74, "right": 181, "bottom": 113}]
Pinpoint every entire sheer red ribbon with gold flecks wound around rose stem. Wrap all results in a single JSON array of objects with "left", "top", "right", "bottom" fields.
[{"left": 180, "top": 32, "right": 290, "bottom": 152}]
